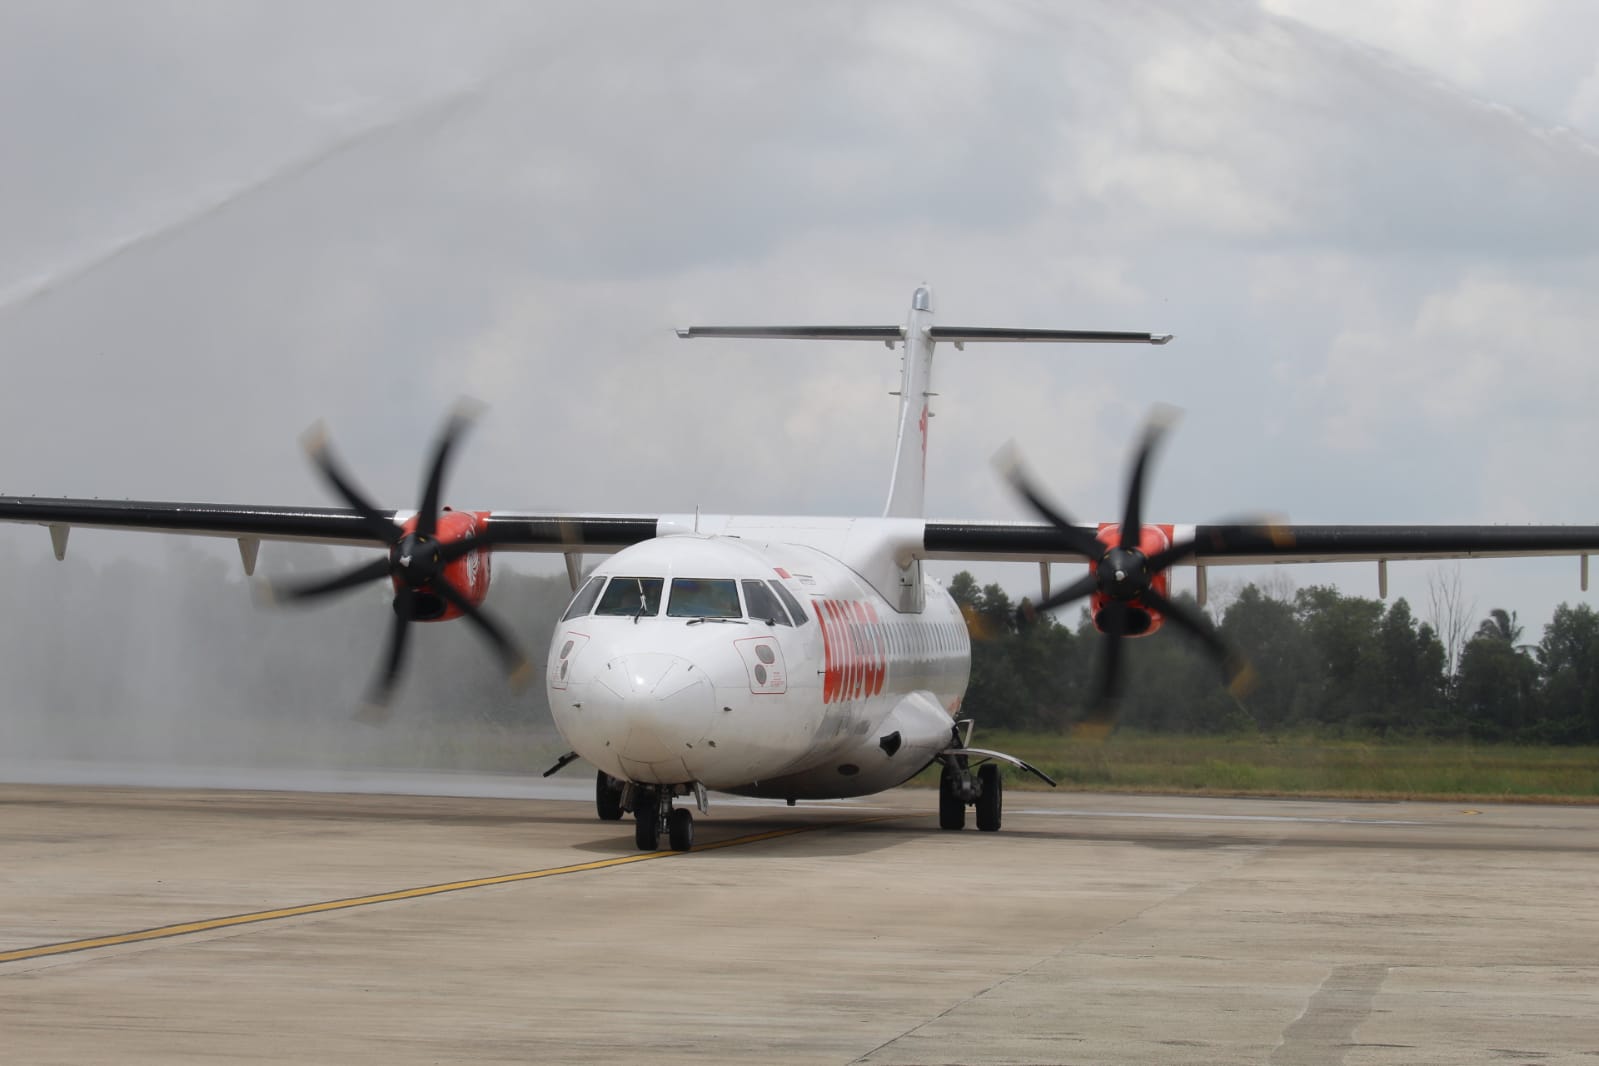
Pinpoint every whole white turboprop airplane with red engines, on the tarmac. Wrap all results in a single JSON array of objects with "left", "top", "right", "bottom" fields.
[{"left": 0, "top": 288, "right": 1599, "bottom": 850}]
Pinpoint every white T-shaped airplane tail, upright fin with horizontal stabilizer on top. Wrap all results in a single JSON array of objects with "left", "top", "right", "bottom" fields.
[{"left": 678, "top": 284, "right": 1172, "bottom": 518}]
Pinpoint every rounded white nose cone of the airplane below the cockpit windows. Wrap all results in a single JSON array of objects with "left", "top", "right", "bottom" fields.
[{"left": 592, "top": 652, "right": 716, "bottom": 764}]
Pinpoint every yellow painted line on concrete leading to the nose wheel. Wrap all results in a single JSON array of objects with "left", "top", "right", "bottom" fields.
[{"left": 0, "top": 818, "right": 883, "bottom": 962}]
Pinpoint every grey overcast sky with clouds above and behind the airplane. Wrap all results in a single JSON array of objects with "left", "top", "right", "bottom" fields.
[{"left": 0, "top": 0, "right": 1599, "bottom": 655}]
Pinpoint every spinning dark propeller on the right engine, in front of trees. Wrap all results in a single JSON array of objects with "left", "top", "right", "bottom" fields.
[{"left": 996, "top": 406, "right": 1254, "bottom": 727}]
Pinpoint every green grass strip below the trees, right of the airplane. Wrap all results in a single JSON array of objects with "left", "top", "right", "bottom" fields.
[{"left": 918, "top": 732, "right": 1599, "bottom": 804}]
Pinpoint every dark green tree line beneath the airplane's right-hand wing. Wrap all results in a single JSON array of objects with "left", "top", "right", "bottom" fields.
[{"left": 950, "top": 571, "right": 1599, "bottom": 745}]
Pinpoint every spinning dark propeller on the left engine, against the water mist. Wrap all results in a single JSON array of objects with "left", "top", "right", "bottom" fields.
[{"left": 259, "top": 401, "right": 532, "bottom": 722}]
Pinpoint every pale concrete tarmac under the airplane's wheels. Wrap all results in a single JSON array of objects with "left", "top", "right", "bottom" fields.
[{"left": 0, "top": 770, "right": 1599, "bottom": 1066}]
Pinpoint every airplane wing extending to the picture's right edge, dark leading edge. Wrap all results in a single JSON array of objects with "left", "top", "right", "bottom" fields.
[{"left": 924, "top": 521, "right": 1599, "bottom": 566}]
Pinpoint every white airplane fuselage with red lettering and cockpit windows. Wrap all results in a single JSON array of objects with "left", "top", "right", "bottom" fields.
[{"left": 547, "top": 531, "right": 971, "bottom": 799}]
